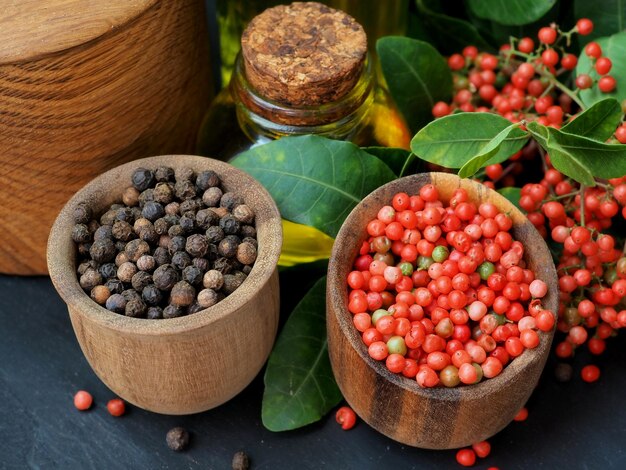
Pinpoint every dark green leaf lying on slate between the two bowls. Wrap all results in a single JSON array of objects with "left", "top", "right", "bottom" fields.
[{"left": 261, "top": 277, "right": 342, "bottom": 431}]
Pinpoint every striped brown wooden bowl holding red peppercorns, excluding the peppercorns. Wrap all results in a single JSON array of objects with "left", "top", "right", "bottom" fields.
[{"left": 326, "top": 173, "right": 559, "bottom": 449}]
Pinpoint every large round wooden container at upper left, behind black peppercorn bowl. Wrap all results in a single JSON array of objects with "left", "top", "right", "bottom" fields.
[{"left": 0, "top": 0, "right": 212, "bottom": 274}]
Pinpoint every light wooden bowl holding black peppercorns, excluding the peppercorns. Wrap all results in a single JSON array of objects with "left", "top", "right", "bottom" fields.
[{"left": 48, "top": 155, "right": 282, "bottom": 414}]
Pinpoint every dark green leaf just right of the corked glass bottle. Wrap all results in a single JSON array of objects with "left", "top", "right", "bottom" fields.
[{"left": 376, "top": 36, "right": 452, "bottom": 132}]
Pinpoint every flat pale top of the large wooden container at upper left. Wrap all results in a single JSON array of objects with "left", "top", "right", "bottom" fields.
[{"left": 0, "top": 0, "right": 157, "bottom": 64}]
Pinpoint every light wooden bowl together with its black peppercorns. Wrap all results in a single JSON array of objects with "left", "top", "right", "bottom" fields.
[{"left": 48, "top": 155, "right": 282, "bottom": 415}]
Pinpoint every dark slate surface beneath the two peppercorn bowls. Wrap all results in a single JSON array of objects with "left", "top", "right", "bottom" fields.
[{"left": 0, "top": 276, "right": 626, "bottom": 469}]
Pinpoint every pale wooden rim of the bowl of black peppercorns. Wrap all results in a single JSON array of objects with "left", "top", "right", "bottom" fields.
[{"left": 47, "top": 154, "right": 282, "bottom": 336}]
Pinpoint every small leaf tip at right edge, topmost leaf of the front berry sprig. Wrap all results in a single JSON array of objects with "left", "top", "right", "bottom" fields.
[{"left": 561, "top": 98, "right": 622, "bottom": 142}]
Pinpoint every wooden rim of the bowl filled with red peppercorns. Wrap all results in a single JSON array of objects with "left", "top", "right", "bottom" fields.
[{"left": 327, "top": 172, "right": 558, "bottom": 402}]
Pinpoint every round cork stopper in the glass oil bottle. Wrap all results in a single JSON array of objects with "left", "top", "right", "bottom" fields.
[{"left": 241, "top": 2, "right": 367, "bottom": 106}]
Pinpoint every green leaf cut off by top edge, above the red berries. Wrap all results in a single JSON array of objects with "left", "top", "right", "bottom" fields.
[{"left": 468, "top": 0, "right": 556, "bottom": 26}]
